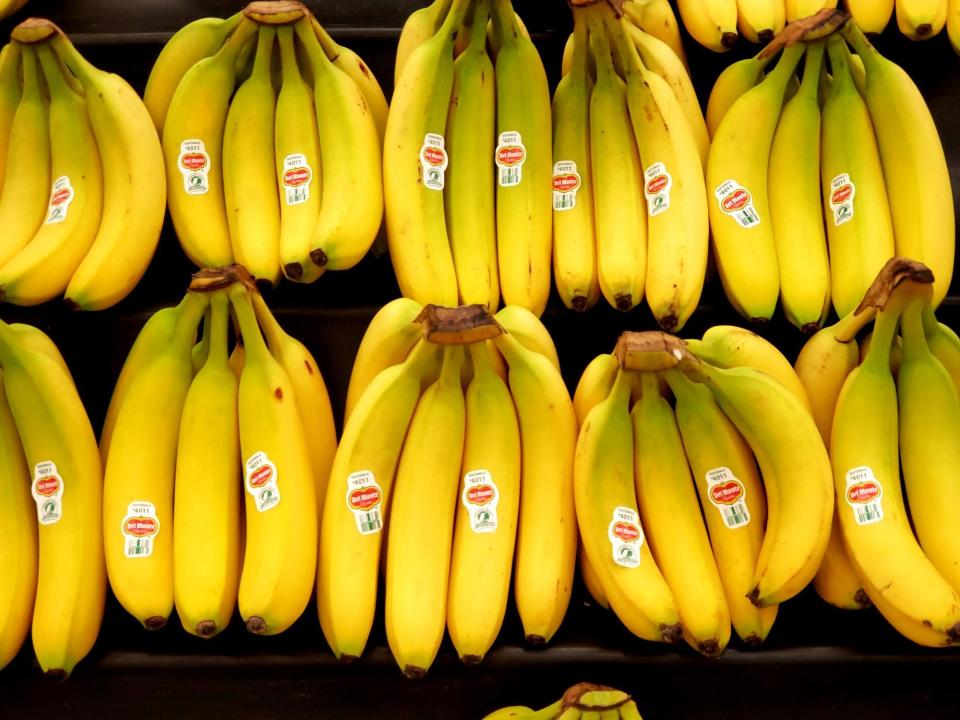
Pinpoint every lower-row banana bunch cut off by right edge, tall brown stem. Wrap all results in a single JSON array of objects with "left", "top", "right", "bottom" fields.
[{"left": 796, "top": 258, "right": 960, "bottom": 647}]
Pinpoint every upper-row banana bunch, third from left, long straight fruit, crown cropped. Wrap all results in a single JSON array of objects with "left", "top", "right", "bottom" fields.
[{"left": 383, "top": 0, "right": 552, "bottom": 315}]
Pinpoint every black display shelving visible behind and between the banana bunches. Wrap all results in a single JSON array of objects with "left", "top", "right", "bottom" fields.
[{"left": 0, "top": 0, "right": 960, "bottom": 720}]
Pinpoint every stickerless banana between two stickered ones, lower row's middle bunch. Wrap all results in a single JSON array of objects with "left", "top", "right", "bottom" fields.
[{"left": 384, "top": 345, "right": 466, "bottom": 678}]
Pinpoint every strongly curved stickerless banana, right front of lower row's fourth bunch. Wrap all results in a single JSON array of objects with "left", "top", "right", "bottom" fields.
[{"left": 682, "top": 354, "right": 833, "bottom": 607}]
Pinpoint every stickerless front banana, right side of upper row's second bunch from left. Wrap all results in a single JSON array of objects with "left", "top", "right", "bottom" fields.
[{"left": 294, "top": 17, "right": 384, "bottom": 270}]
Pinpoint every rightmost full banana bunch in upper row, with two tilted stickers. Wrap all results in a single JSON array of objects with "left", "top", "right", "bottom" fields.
[{"left": 706, "top": 10, "right": 954, "bottom": 333}]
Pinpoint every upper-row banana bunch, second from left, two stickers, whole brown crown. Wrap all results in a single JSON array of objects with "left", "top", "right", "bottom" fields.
[{"left": 144, "top": 0, "right": 387, "bottom": 284}]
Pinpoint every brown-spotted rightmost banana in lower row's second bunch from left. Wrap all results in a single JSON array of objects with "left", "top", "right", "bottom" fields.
[{"left": 253, "top": 294, "right": 337, "bottom": 517}]
